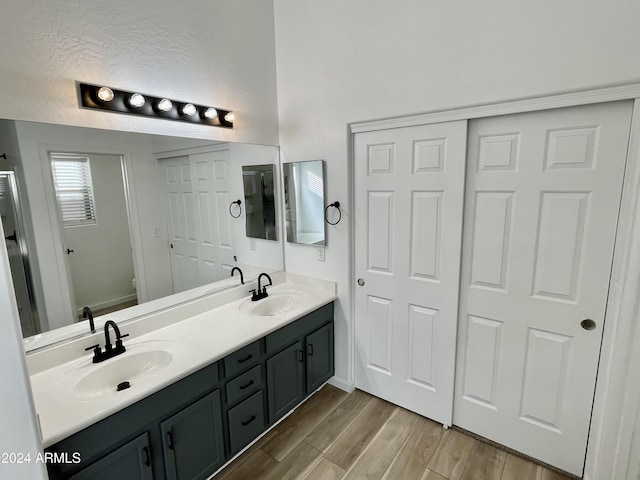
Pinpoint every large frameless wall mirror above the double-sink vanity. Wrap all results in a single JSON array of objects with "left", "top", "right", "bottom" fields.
[{"left": 0, "top": 120, "right": 284, "bottom": 351}]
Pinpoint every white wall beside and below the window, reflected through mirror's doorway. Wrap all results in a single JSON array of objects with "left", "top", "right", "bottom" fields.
[{"left": 63, "top": 154, "right": 139, "bottom": 311}]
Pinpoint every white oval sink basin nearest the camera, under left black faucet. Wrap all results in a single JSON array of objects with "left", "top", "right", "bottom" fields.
[{"left": 52, "top": 341, "right": 188, "bottom": 402}]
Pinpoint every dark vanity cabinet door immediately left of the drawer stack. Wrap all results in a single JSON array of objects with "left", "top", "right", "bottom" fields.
[{"left": 160, "top": 390, "right": 224, "bottom": 480}]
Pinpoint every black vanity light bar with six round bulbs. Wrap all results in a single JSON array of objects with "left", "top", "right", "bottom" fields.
[{"left": 78, "top": 83, "right": 235, "bottom": 128}]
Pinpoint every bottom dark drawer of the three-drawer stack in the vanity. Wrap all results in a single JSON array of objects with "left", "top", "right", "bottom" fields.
[{"left": 227, "top": 390, "right": 264, "bottom": 455}]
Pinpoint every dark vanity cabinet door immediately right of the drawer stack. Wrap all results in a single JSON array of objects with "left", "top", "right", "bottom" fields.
[{"left": 267, "top": 341, "right": 304, "bottom": 423}]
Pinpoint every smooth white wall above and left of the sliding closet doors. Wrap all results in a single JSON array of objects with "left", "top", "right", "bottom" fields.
[{"left": 274, "top": 0, "right": 640, "bottom": 404}]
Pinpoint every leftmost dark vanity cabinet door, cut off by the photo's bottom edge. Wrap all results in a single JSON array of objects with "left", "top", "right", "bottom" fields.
[{"left": 69, "top": 433, "right": 153, "bottom": 480}]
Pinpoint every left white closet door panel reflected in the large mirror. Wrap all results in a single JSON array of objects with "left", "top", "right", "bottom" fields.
[{"left": 159, "top": 156, "right": 200, "bottom": 293}]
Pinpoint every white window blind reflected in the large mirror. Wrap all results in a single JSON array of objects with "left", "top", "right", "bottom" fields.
[{"left": 51, "top": 155, "right": 96, "bottom": 227}]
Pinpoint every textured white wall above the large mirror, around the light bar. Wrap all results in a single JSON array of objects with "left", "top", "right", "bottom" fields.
[{"left": 0, "top": 0, "right": 278, "bottom": 145}]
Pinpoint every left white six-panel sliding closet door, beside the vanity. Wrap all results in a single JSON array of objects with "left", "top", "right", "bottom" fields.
[{"left": 354, "top": 121, "right": 466, "bottom": 425}]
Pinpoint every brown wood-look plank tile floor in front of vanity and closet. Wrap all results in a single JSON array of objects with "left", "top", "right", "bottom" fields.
[{"left": 215, "top": 385, "right": 570, "bottom": 480}]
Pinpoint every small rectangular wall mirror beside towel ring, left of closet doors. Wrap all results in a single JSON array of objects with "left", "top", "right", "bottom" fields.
[{"left": 282, "top": 160, "right": 326, "bottom": 246}]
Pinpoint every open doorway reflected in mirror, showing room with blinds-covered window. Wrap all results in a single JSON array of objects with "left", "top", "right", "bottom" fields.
[{"left": 49, "top": 152, "right": 138, "bottom": 320}]
